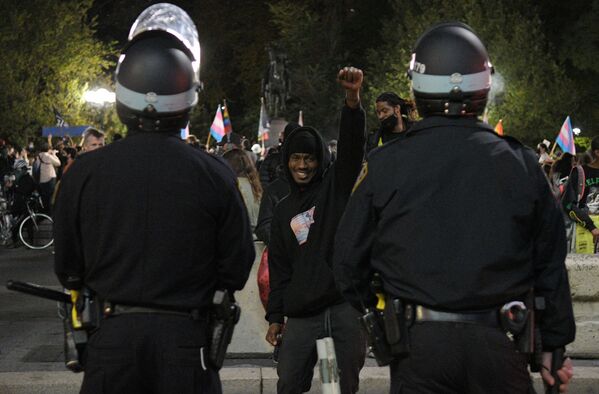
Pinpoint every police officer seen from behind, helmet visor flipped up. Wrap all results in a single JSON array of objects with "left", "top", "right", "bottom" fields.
[{"left": 55, "top": 3, "right": 255, "bottom": 393}]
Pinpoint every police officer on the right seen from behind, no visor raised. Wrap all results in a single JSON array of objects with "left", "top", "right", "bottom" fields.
[{"left": 334, "top": 23, "right": 575, "bottom": 394}]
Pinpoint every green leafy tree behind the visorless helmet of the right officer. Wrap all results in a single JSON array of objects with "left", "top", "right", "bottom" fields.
[{"left": 368, "top": 0, "right": 579, "bottom": 143}]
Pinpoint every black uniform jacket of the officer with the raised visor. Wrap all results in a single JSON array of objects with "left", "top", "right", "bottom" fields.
[{"left": 54, "top": 133, "right": 255, "bottom": 309}]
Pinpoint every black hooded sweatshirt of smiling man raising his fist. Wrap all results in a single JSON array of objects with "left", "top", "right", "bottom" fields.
[{"left": 266, "top": 106, "right": 366, "bottom": 323}]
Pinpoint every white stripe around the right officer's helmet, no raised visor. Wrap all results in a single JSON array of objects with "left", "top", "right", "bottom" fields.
[{"left": 412, "top": 70, "right": 491, "bottom": 94}]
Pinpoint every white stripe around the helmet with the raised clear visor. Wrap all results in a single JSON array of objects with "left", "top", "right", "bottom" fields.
[{"left": 116, "top": 82, "right": 198, "bottom": 113}]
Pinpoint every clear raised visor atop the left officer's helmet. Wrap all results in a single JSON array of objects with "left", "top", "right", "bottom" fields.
[{"left": 129, "top": 3, "right": 200, "bottom": 78}]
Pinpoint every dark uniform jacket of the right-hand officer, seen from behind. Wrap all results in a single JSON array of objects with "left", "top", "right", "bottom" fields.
[{"left": 334, "top": 117, "right": 575, "bottom": 348}]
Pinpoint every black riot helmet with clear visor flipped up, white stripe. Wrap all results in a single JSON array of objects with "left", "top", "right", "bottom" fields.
[{"left": 116, "top": 3, "right": 200, "bottom": 131}]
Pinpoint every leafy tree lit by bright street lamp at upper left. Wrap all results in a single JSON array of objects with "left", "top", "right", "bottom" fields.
[{"left": 0, "top": 0, "right": 114, "bottom": 144}]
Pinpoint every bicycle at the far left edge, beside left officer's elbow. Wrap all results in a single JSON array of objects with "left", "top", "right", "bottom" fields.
[{"left": 0, "top": 191, "right": 54, "bottom": 249}]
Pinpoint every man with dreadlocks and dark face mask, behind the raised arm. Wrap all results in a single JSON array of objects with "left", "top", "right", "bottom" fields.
[{"left": 366, "top": 92, "right": 412, "bottom": 153}]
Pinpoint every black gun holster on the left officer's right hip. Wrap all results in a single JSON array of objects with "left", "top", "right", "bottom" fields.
[{"left": 208, "top": 290, "right": 241, "bottom": 370}]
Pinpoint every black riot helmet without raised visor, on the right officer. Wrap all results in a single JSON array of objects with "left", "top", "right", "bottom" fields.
[{"left": 408, "top": 22, "right": 493, "bottom": 117}]
